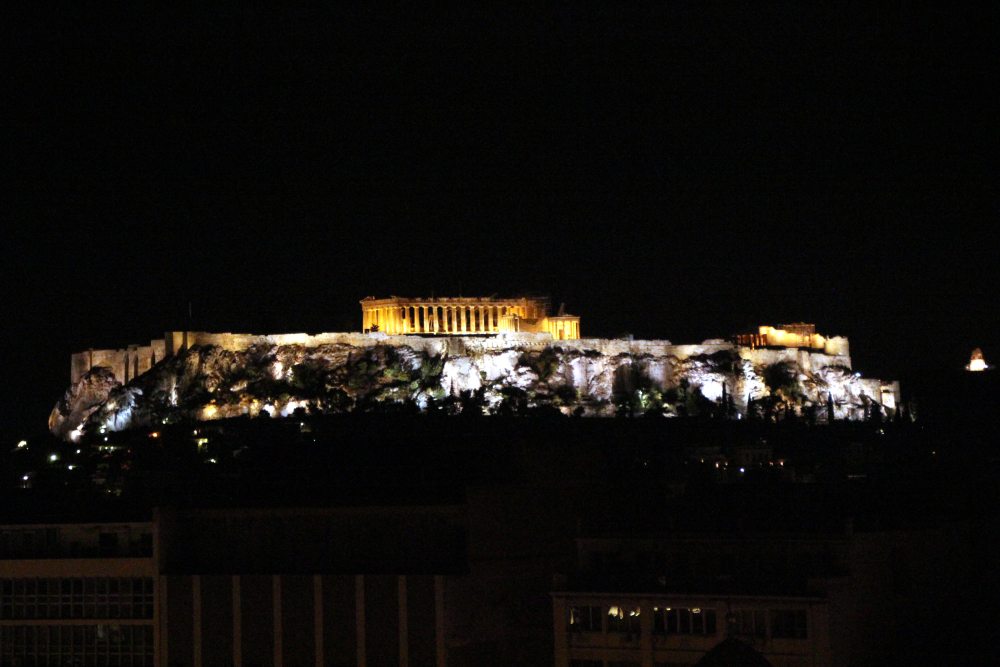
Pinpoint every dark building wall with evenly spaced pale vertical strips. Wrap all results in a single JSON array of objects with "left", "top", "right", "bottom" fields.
[{"left": 159, "top": 574, "right": 443, "bottom": 667}]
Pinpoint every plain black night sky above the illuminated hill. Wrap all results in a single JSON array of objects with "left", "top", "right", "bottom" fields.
[{"left": 0, "top": 2, "right": 1000, "bottom": 433}]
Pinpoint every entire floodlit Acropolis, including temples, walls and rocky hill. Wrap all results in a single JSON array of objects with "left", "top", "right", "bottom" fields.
[{"left": 50, "top": 296, "right": 900, "bottom": 439}]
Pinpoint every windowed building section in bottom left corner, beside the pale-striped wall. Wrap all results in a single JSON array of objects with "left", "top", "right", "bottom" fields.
[{"left": 0, "top": 523, "right": 158, "bottom": 667}]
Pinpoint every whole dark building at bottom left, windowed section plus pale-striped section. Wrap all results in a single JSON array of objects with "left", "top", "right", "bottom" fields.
[{"left": 0, "top": 507, "right": 464, "bottom": 667}]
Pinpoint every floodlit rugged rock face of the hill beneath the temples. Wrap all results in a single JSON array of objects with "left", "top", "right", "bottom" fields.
[{"left": 49, "top": 334, "right": 900, "bottom": 439}]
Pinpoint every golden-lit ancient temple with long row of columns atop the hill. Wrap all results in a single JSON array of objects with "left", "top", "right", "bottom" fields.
[{"left": 361, "top": 296, "right": 580, "bottom": 340}]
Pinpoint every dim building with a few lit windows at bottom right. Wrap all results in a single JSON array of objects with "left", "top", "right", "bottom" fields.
[{"left": 552, "top": 526, "right": 894, "bottom": 667}]
